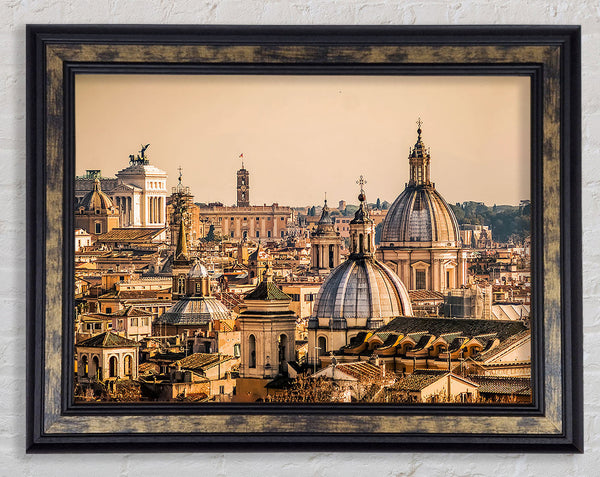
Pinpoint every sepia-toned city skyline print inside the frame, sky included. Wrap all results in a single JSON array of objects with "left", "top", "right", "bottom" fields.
[{"left": 73, "top": 75, "right": 532, "bottom": 405}]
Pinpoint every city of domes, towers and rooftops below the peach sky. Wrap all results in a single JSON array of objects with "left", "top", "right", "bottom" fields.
[{"left": 74, "top": 114, "right": 532, "bottom": 405}]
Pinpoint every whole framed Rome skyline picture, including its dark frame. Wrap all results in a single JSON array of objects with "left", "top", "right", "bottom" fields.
[{"left": 27, "top": 25, "right": 583, "bottom": 452}]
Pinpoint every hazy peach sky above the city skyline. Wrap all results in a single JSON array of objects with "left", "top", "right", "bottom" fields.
[{"left": 76, "top": 75, "right": 530, "bottom": 206}]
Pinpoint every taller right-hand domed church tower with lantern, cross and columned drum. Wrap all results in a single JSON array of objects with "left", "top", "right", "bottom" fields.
[{"left": 377, "top": 119, "right": 467, "bottom": 292}]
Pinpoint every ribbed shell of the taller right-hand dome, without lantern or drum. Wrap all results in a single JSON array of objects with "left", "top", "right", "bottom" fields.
[{"left": 381, "top": 185, "right": 460, "bottom": 247}]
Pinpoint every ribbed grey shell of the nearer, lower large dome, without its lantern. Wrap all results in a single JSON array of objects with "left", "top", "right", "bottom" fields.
[{"left": 312, "top": 258, "right": 412, "bottom": 328}]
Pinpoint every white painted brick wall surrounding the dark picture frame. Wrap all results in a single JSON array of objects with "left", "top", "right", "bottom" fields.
[{"left": 0, "top": 0, "right": 600, "bottom": 477}]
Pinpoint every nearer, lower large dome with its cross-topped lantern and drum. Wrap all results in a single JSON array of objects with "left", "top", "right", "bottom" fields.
[{"left": 308, "top": 177, "right": 413, "bottom": 363}]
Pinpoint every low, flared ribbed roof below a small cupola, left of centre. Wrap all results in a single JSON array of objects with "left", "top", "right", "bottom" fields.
[{"left": 156, "top": 296, "right": 231, "bottom": 325}]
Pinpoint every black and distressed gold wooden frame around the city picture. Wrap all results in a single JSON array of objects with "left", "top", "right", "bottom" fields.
[{"left": 27, "top": 25, "right": 583, "bottom": 452}]
